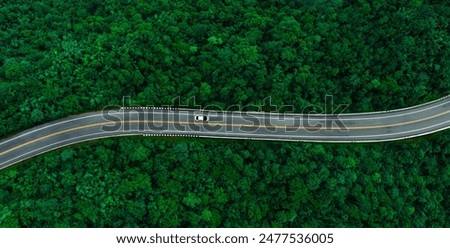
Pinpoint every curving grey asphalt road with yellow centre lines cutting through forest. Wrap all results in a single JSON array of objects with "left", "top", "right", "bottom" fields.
[{"left": 0, "top": 96, "right": 450, "bottom": 169}]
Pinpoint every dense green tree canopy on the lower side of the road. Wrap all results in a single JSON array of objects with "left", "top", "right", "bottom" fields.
[{"left": 0, "top": 135, "right": 450, "bottom": 227}]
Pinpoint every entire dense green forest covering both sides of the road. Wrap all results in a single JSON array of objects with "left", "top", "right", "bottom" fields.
[{"left": 0, "top": 0, "right": 450, "bottom": 227}]
